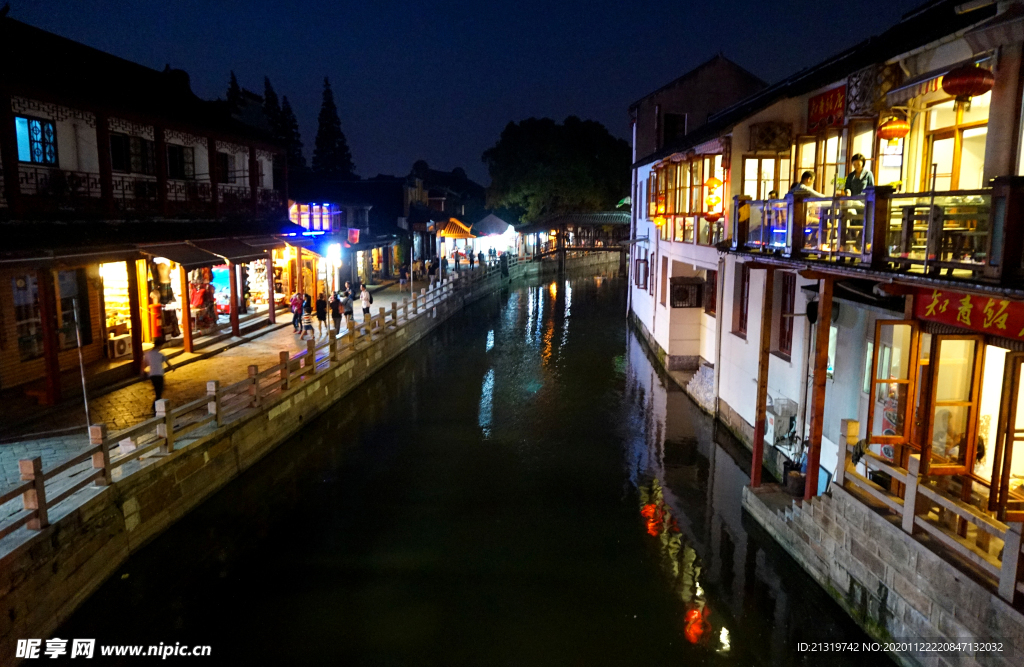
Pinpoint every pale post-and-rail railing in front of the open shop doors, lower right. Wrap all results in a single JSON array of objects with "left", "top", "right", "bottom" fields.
[{"left": 836, "top": 419, "right": 1024, "bottom": 602}]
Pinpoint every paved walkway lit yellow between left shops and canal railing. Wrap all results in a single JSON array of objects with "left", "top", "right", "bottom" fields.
[{"left": 0, "top": 282, "right": 426, "bottom": 489}]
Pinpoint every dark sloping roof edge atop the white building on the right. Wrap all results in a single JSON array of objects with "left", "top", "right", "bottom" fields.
[{"left": 633, "top": 0, "right": 996, "bottom": 167}]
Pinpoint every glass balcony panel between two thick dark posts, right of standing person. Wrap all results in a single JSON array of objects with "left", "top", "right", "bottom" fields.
[{"left": 885, "top": 190, "right": 992, "bottom": 275}]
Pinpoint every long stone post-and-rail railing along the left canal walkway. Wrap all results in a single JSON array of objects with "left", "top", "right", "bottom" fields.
[{"left": 0, "top": 255, "right": 518, "bottom": 539}]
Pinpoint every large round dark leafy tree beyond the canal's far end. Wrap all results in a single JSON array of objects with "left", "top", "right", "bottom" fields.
[{"left": 482, "top": 116, "right": 631, "bottom": 222}]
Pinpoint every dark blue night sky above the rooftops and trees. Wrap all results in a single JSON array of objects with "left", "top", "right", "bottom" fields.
[{"left": 16, "top": 0, "right": 921, "bottom": 183}]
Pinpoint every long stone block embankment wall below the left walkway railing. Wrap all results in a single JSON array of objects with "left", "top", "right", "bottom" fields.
[{"left": 0, "top": 264, "right": 522, "bottom": 664}]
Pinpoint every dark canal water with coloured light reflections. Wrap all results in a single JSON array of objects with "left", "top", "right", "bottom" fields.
[{"left": 54, "top": 270, "right": 884, "bottom": 666}]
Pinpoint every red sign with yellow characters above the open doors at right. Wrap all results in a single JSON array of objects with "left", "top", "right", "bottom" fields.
[{"left": 913, "top": 289, "right": 1024, "bottom": 340}]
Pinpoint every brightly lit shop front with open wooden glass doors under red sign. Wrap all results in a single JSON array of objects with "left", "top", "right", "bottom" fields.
[{"left": 868, "top": 288, "right": 1024, "bottom": 522}]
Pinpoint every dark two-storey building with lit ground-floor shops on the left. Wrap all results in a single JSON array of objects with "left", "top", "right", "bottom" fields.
[{"left": 0, "top": 17, "right": 293, "bottom": 403}]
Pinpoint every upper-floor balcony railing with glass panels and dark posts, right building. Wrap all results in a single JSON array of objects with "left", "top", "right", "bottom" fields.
[{"left": 732, "top": 181, "right": 1024, "bottom": 282}]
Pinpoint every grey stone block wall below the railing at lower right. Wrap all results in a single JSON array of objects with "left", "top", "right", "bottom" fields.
[{"left": 743, "top": 485, "right": 1024, "bottom": 667}]
